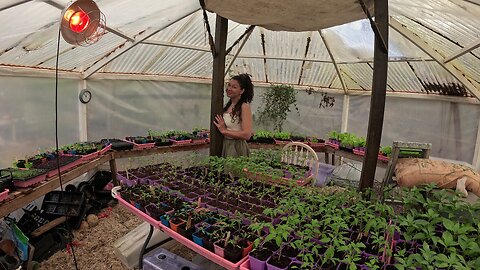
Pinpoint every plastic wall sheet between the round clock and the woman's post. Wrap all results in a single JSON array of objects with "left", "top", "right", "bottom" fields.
[{"left": 87, "top": 80, "right": 211, "bottom": 140}]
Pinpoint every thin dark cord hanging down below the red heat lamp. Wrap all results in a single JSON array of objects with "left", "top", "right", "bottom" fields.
[{"left": 55, "top": 21, "right": 78, "bottom": 270}]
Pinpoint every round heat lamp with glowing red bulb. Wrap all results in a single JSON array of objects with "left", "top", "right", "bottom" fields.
[{"left": 60, "top": 0, "right": 105, "bottom": 46}]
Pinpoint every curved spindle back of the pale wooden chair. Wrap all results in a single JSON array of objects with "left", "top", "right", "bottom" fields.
[{"left": 281, "top": 142, "right": 319, "bottom": 184}]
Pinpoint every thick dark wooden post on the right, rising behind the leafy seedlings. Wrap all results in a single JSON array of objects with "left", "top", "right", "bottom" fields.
[{"left": 359, "top": 0, "right": 389, "bottom": 190}]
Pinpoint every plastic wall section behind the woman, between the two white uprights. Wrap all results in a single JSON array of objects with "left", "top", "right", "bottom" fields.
[{"left": 87, "top": 80, "right": 343, "bottom": 140}]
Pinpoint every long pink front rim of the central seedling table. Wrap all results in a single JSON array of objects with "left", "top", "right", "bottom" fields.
[{"left": 115, "top": 193, "right": 248, "bottom": 270}]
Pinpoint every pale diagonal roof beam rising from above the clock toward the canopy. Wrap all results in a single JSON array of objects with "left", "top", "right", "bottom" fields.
[{"left": 83, "top": 6, "right": 200, "bottom": 79}]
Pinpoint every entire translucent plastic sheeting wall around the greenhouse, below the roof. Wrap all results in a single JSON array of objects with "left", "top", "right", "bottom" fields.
[{"left": 0, "top": 77, "right": 480, "bottom": 167}]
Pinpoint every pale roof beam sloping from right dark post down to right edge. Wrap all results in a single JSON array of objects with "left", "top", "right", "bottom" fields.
[{"left": 390, "top": 17, "right": 480, "bottom": 100}]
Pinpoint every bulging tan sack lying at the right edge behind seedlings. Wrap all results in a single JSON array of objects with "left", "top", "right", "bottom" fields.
[{"left": 395, "top": 158, "right": 480, "bottom": 196}]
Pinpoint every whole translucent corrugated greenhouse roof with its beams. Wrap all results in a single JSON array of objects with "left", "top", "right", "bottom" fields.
[{"left": 0, "top": 0, "right": 480, "bottom": 97}]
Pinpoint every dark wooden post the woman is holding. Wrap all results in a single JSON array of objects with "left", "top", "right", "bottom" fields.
[{"left": 210, "top": 15, "right": 228, "bottom": 157}]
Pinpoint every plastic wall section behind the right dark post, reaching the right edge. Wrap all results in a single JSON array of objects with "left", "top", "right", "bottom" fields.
[{"left": 348, "top": 96, "right": 480, "bottom": 164}]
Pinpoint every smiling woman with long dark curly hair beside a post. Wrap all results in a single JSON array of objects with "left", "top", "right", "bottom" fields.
[{"left": 213, "top": 74, "right": 253, "bottom": 157}]
